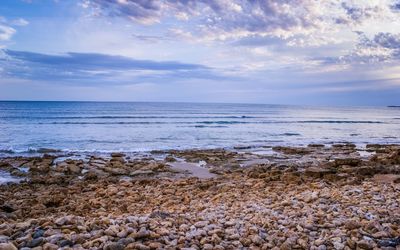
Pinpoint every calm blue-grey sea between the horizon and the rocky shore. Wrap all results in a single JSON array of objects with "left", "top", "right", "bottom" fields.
[{"left": 0, "top": 102, "right": 400, "bottom": 156}]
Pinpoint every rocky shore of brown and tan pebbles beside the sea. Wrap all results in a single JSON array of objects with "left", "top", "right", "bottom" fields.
[{"left": 0, "top": 143, "right": 400, "bottom": 250}]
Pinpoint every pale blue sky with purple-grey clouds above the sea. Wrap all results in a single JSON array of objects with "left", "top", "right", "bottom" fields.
[{"left": 0, "top": 0, "right": 400, "bottom": 105}]
